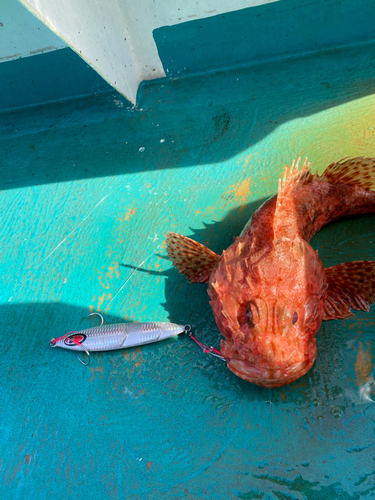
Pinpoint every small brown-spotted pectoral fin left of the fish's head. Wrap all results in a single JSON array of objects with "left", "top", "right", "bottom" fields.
[{"left": 166, "top": 233, "right": 220, "bottom": 283}]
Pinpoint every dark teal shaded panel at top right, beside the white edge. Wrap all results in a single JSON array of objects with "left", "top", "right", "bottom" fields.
[{"left": 153, "top": 0, "right": 375, "bottom": 76}]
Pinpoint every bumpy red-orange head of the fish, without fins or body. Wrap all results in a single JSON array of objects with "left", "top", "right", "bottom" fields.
[{"left": 209, "top": 236, "right": 327, "bottom": 387}]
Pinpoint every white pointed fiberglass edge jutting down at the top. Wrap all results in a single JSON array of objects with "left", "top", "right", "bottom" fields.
[{"left": 20, "top": 0, "right": 278, "bottom": 104}]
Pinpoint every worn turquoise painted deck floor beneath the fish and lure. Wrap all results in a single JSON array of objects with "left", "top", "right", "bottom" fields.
[{"left": 0, "top": 40, "right": 375, "bottom": 500}]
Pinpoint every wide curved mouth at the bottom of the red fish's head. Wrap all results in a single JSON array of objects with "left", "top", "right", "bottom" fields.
[{"left": 227, "top": 356, "right": 315, "bottom": 388}]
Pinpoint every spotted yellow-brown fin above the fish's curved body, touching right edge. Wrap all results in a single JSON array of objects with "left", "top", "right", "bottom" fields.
[{"left": 318, "top": 156, "right": 375, "bottom": 191}]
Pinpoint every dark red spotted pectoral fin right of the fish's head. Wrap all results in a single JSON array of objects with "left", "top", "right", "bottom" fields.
[{"left": 323, "top": 260, "right": 375, "bottom": 320}]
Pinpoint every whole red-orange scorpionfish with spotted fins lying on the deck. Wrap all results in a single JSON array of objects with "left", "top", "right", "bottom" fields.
[{"left": 167, "top": 158, "right": 375, "bottom": 387}]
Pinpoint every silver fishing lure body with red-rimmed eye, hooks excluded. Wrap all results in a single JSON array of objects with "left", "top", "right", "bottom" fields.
[{"left": 55, "top": 322, "right": 186, "bottom": 352}]
